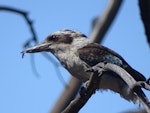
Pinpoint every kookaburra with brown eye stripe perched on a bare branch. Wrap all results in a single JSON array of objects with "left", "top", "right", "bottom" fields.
[{"left": 22, "top": 29, "right": 149, "bottom": 106}]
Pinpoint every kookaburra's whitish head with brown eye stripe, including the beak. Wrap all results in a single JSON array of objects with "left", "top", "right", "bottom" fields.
[{"left": 22, "top": 30, "right": 86, "bottom": 56}]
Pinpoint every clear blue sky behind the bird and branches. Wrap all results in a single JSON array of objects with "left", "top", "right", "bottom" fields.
[{"left": 0, "top": 0, "right": 150, "bottom": 113}]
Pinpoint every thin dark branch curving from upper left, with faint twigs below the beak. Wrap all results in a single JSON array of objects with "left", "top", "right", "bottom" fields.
[{"left": 0, "top": 6, "right": 66, "bottom": 85}]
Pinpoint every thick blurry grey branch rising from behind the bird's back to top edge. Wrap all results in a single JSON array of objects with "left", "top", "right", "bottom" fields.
[{"left": 90, "top": 0, "right": 122, "bottom": 43}]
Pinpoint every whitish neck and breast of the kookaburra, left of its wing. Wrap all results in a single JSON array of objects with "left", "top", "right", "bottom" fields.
[{"left": 54, "top": 38, "right": 89, "bottom": 81}]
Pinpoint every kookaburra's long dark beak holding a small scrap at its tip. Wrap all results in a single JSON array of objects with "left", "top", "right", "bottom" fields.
[{"left": 21, "top": 42, "right": 51, "bottom": 58}]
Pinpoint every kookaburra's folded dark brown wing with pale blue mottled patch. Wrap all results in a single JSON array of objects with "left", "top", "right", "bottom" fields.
[{"left": 78, "top": 43, "right": 146, "bottom": 81}]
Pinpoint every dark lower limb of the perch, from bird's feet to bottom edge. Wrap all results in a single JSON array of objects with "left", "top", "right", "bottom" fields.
[{"left": 61, "top": 66, "right": 104, "bottom": 113}]
